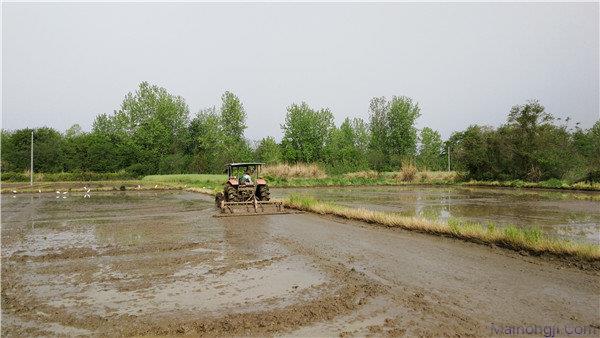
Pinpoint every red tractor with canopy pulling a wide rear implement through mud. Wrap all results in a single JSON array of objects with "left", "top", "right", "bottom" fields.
[{"left": 215, "top": 162, "right": 286, "bottom": 215}]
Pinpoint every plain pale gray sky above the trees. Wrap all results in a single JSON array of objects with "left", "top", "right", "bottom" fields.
[{"left": 2, "top": 3, "right": 600, "bottom": 139}]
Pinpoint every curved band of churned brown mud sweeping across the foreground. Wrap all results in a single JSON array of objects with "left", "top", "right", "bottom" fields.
[{"left": 2, "top": 248, "right": 383, "bottom": 336}]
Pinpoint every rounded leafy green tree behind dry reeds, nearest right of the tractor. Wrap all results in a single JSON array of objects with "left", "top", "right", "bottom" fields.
[{"left": 281, "top": 102, "right": 334, "bottom": 163}]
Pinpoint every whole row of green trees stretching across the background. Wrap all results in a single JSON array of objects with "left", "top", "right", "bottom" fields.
[{"left": 1, "top": 82, "right": 600, "bottom": 181}]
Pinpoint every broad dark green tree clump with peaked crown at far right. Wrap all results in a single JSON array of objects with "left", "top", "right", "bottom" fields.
[{"left": 448, "top": 100, "right": 587, "bottom": 181}]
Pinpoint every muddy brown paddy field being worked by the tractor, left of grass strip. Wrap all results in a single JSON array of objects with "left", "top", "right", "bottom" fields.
[{"left": 1, "top": 191, "right": 600, "bottom": 337}]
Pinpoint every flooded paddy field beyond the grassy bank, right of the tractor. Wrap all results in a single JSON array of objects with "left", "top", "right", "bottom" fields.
[{"left": 272, "top": 186, "right": 600, "bottom": 243}]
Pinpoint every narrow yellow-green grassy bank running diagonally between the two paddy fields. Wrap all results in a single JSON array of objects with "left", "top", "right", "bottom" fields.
[{"left": 285, "top": 195, "right": 600, "bottom": 262}]
